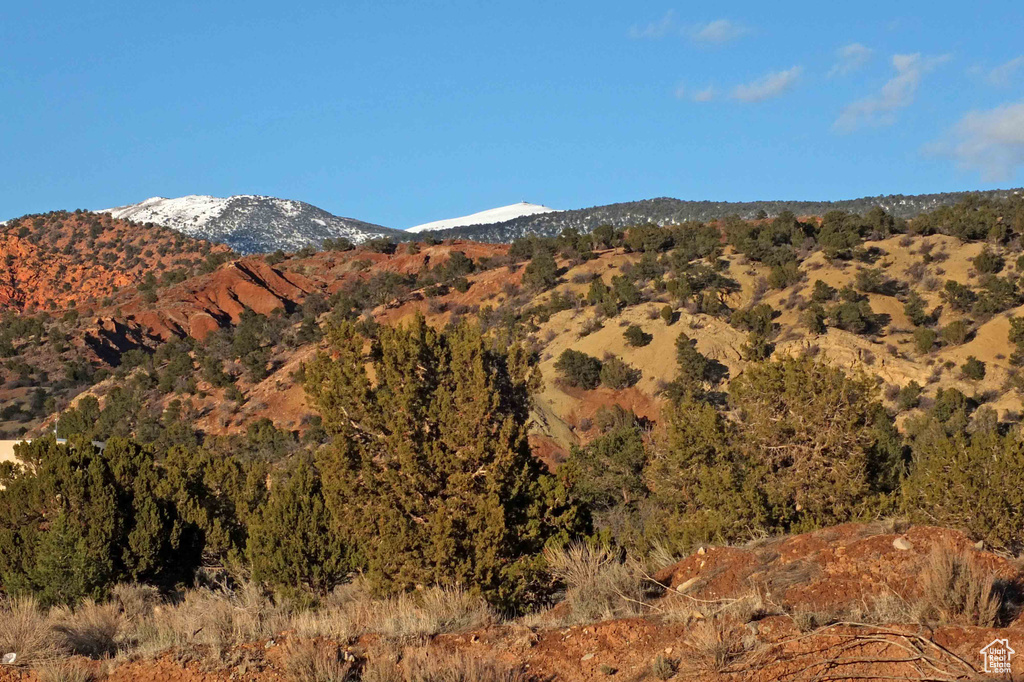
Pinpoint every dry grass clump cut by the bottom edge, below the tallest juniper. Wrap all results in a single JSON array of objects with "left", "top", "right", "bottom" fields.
[{"left": 361, "top": 648, "right": 529, "bottom": 682}]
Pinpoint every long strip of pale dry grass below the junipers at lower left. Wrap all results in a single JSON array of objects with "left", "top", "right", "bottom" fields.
[{"left": 0, "top": 582, "right": 494, "bottom": 671}]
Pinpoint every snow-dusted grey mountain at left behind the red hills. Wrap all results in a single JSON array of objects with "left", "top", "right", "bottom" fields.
[{"left": 100, "top": 195, "right": 408, "bottom": 253}]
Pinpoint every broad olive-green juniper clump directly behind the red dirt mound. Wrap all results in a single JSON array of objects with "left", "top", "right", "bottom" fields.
[{"left": 644, "top": 358, "right": 902, "bottom": 548}]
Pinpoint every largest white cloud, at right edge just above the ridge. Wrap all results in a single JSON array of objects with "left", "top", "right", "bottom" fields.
[{"left": 926, "top": 101, "right": 1024, "bottom": 181}]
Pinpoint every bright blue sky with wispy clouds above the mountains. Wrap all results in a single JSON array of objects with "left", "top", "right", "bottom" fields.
[{"left": 0, "top": 0, "right": 1024, "bottom": 227}]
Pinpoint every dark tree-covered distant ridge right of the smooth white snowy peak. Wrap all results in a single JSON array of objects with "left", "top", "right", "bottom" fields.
[{"left": 432, "top": 188, "right": 1024, "bottom": 243}]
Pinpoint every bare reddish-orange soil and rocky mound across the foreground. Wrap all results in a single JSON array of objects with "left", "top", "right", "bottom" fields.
[{"left": 0, "top": 522, "right": 1024, "bottom": 682}]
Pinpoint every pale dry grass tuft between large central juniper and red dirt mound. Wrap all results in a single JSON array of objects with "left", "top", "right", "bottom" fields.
[{"left": 545, "top": 544, "right": 648, "bottom": 623}]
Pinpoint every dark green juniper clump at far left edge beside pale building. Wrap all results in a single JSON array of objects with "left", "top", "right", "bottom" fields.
[{"left": 0, "top": 437, "right": 202, "bottom": 604}]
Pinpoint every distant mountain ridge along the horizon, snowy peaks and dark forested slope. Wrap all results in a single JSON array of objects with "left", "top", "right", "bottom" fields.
[{"left": 14, "top": 184, "right": 1024, "bottom": 254}]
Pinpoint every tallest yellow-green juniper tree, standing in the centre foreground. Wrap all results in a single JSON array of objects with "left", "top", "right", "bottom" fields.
[{"left": 305, "top": 316, "right": 586, "bottom": 607}]
